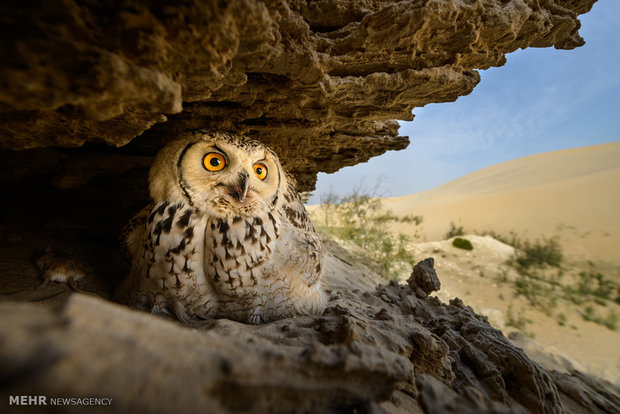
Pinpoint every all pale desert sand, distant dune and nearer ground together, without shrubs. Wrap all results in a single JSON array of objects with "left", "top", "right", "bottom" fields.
[{"left": 309, "top": 142, "right": 620, "bottom": 384}]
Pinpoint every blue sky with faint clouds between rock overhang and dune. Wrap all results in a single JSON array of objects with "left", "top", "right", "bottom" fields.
[{"left": 310, "top": 0, "right": 620, "bottom": 204}]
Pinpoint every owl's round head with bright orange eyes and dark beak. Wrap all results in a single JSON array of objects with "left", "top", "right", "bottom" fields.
[{"left": 149, "top": 130, "right": 287, "bottom": 217}]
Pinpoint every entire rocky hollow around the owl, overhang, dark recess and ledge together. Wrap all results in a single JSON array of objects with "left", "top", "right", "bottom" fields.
[{"left": 0, "top": 0, "right": 618, "bottom": 413}]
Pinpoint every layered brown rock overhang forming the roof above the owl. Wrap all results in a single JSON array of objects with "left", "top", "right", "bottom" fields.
[{"left": 0, "top": 0, "right": 595, "bottom": 189}]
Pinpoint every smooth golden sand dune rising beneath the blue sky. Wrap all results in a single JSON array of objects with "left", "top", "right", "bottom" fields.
[{"left": 384, "top": 142, "right": 620, "bottom": 264}]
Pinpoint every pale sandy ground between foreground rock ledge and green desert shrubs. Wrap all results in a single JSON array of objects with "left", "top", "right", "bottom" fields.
[{"left": 401, "top": 235, "right": 620, "bottom": 384}]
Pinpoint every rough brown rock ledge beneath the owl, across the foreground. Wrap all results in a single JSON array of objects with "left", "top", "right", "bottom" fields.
[{"left": 0, "top": 255, "right": 619, "bottom": 413}]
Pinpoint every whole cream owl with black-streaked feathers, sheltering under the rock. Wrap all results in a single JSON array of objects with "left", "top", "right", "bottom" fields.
[{"left": 117, "top": 130, "right": 326, "bottom": 324}]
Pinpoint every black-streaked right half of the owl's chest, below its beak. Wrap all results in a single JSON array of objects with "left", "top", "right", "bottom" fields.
[{"left": 204, "top": 213, "right": 279, "bottom": 294}]
